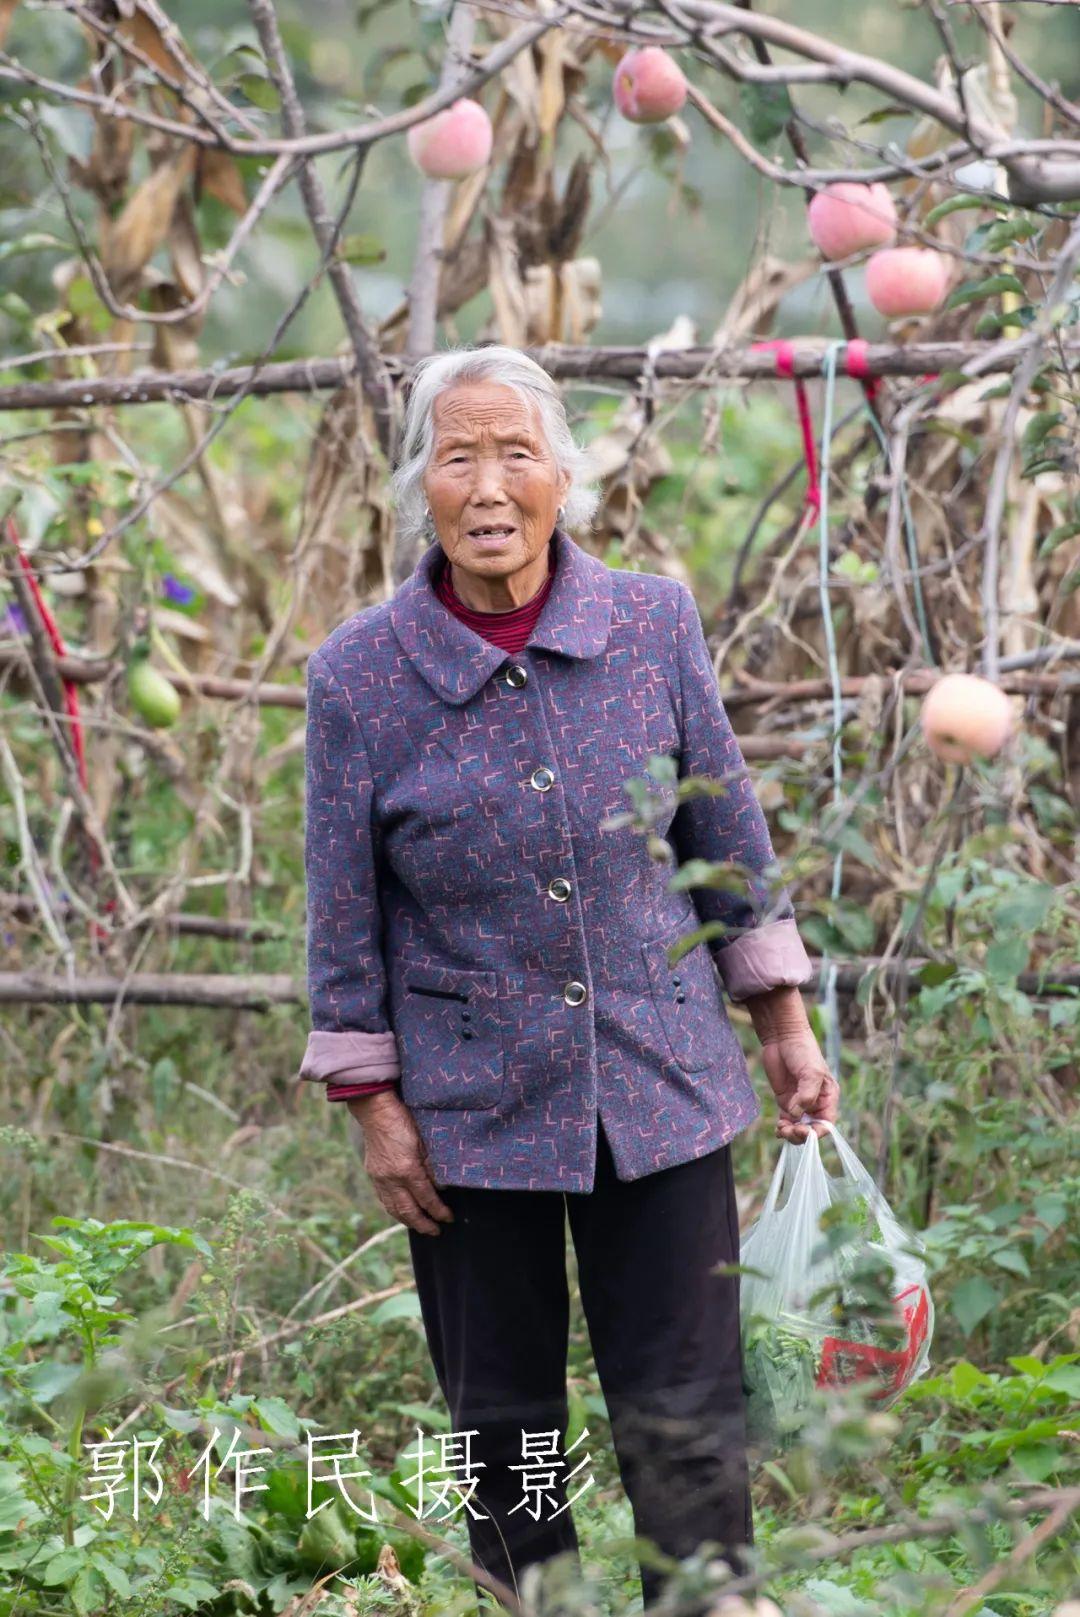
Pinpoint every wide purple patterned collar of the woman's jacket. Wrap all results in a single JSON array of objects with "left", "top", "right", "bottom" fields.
[{"left": 390, "top": 527, "right": 611, "bottom": 702}]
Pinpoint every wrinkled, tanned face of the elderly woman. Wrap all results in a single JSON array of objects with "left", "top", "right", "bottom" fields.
[{"left": 424, "top": 382, "right": 569, "bottom": 579}]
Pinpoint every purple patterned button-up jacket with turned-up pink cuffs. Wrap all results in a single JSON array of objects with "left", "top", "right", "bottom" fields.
[{"left": 301, "top": 529, "right": 812, "bottom": 1190}]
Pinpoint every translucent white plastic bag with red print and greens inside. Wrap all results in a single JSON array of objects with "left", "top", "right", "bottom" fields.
[{"left": 740, "top": 1124, "right": 934, "bottom": 1438}]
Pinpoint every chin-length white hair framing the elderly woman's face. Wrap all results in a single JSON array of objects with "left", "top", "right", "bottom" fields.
[{"left": 391, "top": 343, "right": 600, "bottom": 545}]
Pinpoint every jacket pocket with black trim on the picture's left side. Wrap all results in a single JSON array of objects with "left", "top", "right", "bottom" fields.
[{"left": 394, "top": 965, "right": 504, "bottom": 1111}]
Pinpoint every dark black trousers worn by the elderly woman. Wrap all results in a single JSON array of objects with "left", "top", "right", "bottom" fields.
[{"left": 409, "top": 1127, "right": 753, "bottom": 1604}]
